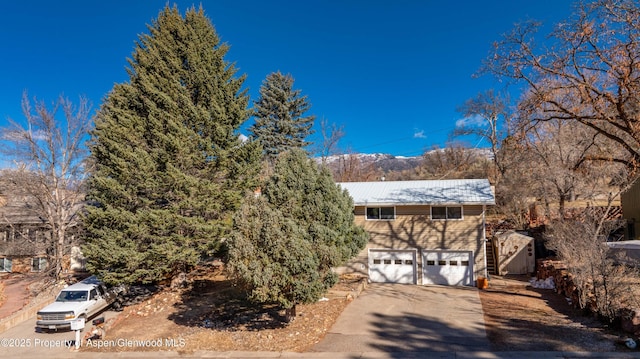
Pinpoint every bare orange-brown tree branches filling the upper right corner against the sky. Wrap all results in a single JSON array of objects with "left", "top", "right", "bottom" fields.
[{"left": 484, "top": 0, "right": 640, "bottom": 168}]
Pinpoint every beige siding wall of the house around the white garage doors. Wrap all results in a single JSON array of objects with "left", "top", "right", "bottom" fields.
[{"left": 339, "top": 205, "right": 485, "bottom": 275}]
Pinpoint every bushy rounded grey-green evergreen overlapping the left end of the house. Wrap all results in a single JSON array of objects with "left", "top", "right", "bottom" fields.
[{"left": 229, "top": 149, "right": 367, "bottom": 320}]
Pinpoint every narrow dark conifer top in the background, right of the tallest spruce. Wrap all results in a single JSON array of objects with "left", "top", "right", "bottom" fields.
[{"left": 249, "top": 72, "right": 315, "bottom": 160}]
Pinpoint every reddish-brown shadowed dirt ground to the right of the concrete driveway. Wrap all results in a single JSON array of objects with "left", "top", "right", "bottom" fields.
[{"left": 479, "top": 279, "right": 628, "bottom": 352}]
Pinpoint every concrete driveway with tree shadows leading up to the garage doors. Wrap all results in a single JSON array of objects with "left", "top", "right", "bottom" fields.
[{"left": 312, "top": 283, "right": 489, "bottom": 354}]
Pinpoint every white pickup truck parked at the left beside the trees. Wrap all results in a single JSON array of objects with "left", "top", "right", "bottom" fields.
[{"left": 36, "top": 277, "right": 125, "bottom": 331}]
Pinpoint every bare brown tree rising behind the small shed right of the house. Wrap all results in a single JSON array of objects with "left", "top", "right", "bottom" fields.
[{"left": 497, "top": 83, "right": 624, "bottom": 228}]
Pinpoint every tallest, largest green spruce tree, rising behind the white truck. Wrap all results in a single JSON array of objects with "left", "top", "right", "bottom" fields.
[{"left": 83, "top": 7, "right": 260, "bottom": 283}]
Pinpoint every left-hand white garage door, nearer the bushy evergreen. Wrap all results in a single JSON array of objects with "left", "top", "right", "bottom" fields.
[{"left": 369, "top": 249, "right": 417, "bottom": 284}]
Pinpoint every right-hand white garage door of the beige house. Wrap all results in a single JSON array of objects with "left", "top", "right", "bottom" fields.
[{"left": 422, "top": 250, "right": 473, "bottom": 285}]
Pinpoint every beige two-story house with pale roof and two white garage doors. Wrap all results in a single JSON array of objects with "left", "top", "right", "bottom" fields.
[{"left": 337, "top": 179, "right": 495, "bottom": 285}]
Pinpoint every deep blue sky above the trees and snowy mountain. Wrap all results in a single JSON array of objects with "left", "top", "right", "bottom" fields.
[{"left": 0, "top": 0, "right": 571, "bottom": 156}]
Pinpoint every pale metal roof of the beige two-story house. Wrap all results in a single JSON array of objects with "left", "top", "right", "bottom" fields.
[{"left": 338, "top": 179, "right": 495, "bottom": 206}]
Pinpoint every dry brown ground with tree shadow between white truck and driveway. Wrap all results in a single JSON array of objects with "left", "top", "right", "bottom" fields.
[{"left": 84, "top": 273, "right": 355, "bottom": 353}]
